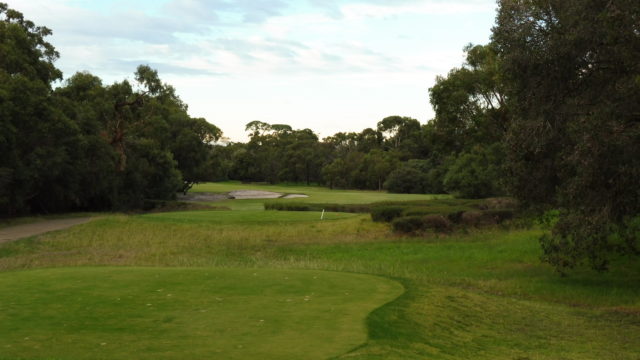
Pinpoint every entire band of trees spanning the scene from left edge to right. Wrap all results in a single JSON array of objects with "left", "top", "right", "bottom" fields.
[{"left": 0, "top": 0, "right": 640, "bottom": 269}]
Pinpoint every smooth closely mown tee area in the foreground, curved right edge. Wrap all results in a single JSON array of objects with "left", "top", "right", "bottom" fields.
[{"left": 0, "top": 267, "right": 402, "bottom": 359}]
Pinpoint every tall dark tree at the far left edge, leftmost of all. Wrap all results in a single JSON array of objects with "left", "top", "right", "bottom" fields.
[{"left": 0, "top": 3, "right": 74, "bottom": 215}]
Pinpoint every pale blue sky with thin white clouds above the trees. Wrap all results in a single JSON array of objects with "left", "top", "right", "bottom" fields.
[{"left": 4, "top": 0, "right": 496, "bottom": 141}]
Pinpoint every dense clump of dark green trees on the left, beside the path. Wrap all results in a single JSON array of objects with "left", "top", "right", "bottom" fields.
[{"left": 0, "top": 3, "right": 221, "bottom": 216}]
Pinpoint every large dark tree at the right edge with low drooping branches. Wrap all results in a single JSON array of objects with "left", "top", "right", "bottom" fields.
[{"left": 493, "top": 0, "right": 640, "bottom": 271}]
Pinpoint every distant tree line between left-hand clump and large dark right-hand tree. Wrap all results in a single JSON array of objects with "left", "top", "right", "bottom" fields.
[{"left": 211, "top": 45, "right": 510, "bottom": 198}]
